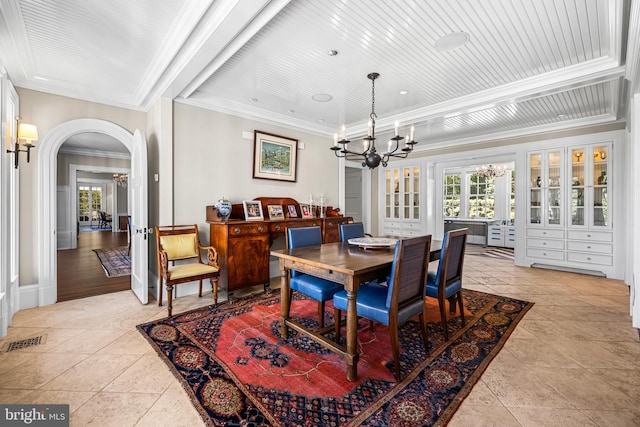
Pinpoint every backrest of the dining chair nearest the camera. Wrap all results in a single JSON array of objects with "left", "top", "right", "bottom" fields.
[{"left": 386, "top": 235, "right": 431, "bottom": 312}]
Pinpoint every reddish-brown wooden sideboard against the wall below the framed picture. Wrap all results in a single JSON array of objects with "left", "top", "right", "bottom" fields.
[{"left": 207, "top": 203, "right": 353, "bottom": 299}]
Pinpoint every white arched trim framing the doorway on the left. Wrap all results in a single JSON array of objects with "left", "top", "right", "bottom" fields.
[{"left": 38, "top": 119, "right": 148, "bottom": 306}]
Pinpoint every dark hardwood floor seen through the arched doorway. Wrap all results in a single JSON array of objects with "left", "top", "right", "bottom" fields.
[{"left": 58, "top": 231, "right": 131, "bottom": 302}]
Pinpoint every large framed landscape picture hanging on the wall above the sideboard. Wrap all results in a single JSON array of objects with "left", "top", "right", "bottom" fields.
[{"left": 253, "top": 130, "right": 298, "bottom": 182}]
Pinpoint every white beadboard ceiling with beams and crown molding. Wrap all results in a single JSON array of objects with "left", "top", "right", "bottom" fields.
[{"left": 0, "top": 0, "right": 639, "bottom": 154}]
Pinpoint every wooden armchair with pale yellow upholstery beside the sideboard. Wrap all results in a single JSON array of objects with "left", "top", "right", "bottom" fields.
[{"left": 155, "top": 224, "right": 220, "bottom": 316}]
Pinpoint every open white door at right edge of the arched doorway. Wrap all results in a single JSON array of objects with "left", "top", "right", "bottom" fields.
[{"left": 128, "top": 129, "right": 149, "bottom": 304}]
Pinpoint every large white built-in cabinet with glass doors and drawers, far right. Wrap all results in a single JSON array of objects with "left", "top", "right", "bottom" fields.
[{"left": 525, "top": 142, "right": 616, "bottom": 275}]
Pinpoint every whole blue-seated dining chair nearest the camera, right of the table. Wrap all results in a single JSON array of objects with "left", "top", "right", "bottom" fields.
[{"left": 333, "top": 235, "right": 431, "bottom": 381}]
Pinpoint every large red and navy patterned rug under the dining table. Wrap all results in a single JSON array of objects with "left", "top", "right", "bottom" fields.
[{"left": 138, "top": 290, "right": 533, "bottom": 426}]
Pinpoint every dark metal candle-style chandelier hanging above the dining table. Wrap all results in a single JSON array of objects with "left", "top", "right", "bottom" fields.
[{"left": 331, "top": 73, "right": 417, "bottom": 169}]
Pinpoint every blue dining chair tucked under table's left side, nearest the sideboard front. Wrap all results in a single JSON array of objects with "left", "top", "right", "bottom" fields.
[{"left": 286, "top": 226, "right": 343, "bottom": 328}]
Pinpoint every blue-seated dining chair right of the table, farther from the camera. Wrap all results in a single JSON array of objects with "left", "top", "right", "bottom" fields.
[{"left": 426, "top": 228, "right": 469, "bottom": 341}]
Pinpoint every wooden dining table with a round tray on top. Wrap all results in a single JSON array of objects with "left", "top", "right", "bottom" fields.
[{"left": 271, "top": 240, "right": 442, "bottom": 381}]
